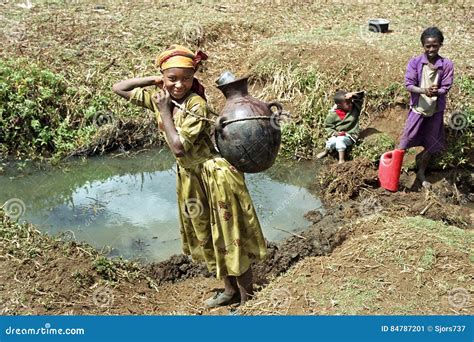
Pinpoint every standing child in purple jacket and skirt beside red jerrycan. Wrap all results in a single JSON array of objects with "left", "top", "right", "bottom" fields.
[{"left": 400, "top": 27, "right": 454, "bottom": 187}]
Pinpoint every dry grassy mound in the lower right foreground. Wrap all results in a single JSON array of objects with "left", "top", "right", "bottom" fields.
[{"left": 242, "top": 215, "right": 474, "bottom": 315}]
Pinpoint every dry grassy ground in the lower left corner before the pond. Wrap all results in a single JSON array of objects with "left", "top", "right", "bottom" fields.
[{"left": 0, "top": 210, "right": 160, "bottom": 315}]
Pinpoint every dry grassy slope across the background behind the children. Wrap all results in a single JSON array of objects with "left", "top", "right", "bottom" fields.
[{"left": 0, "top": 1, "right": 474, "bottom": 156}]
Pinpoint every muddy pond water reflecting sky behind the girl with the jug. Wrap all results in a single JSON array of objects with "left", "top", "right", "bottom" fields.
[{"left": 0, "top": 149, "right": 324, "bottom": 262}]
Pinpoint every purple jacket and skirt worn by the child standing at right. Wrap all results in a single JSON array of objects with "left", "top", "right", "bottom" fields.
[{"left": 400, "top": 54, "right": 454, "bottom": 153}]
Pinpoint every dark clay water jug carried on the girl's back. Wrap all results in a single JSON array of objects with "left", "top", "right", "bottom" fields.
[{"left": 215, "top": 72, "right": 282, "bottom": 173}]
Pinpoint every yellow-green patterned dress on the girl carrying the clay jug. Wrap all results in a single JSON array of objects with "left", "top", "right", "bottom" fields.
[{"left": 130, "top": 88, "right": 266, "bottom": 278}]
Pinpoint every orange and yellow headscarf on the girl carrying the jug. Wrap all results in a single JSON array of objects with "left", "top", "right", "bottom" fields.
[{"left": 156, "top": 45, "right": 207, "bottom": 71}]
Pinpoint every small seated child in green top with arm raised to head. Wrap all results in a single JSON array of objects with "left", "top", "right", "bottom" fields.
[{"left": 316, "top": 90, "right": 364, "bottom": 164}]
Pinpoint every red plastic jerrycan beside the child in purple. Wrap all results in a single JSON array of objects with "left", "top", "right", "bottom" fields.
[{"left": 379, "top": 150, "right": 405, "bottom": 191}]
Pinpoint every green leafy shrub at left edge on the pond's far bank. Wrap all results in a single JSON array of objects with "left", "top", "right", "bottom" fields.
[{"left": 0, "top": 59, "right": 104, "bottom": 157}]
